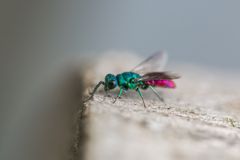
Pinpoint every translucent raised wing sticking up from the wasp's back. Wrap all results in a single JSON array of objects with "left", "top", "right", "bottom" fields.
[{"left": 132, "top": 51, "right": 168, "bottom": 74}]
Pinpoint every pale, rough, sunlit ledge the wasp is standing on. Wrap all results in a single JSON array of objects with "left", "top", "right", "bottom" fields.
[{"left": 70, "top": 52, "right": 240, "bottom": 160}]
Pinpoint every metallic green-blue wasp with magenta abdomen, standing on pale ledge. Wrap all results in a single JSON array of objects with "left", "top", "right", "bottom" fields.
[{"left": 85, "top": 52, "right": 180, "bottom": 107}]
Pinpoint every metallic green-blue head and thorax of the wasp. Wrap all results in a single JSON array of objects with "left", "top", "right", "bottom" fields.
[{"left": 105, "top": 72, "right": 148, "bottom": 91}]
